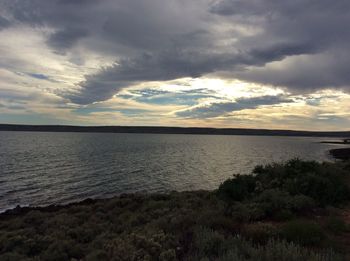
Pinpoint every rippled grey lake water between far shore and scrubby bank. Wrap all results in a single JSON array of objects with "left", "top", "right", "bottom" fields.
[{"left": 0, "top": 132, "right": 344, "bottom": 211}]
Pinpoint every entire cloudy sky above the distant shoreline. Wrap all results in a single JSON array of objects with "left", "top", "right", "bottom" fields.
[{"left": 0, "top": 0, "right": 350, "bottom": 130}]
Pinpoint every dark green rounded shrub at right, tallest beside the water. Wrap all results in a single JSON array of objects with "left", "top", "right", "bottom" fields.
[{"left": 253, "top": 159, "right": 350, "bottom": 206}]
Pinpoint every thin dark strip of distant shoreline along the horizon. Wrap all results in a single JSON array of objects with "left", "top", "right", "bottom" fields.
[{"left": 0, "top": 124, "right": 350, "bottom": 138}]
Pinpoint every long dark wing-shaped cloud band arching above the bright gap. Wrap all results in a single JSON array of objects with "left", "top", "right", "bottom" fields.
[{"left": 66, "top": 43, "right": 316, "bottom": 104}]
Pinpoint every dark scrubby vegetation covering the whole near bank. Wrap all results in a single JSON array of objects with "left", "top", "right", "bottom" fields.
[{"left": 0, "top": 159, "right": 350, "bottom": 261}]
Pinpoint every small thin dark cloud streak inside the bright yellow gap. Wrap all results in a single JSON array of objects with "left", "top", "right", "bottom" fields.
[{"left": 177, "top": 96, "right": 293, "bottom": 119}]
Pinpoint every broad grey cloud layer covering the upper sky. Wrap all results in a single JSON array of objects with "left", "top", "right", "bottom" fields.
[{"left": 0, "top": 0, "right": 350, "bottom": 104}]
